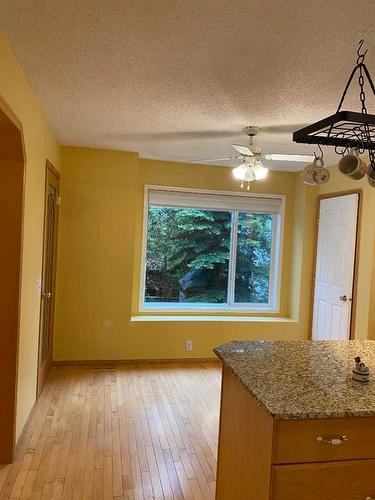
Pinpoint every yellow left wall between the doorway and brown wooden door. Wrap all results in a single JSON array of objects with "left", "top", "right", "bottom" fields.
[{"left": 0, "top": 33, "right": 60, "bottom": 437}]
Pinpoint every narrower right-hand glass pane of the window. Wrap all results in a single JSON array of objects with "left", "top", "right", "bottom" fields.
[{"left": 234, "top": 213, "right": 273, "bottom": 304}]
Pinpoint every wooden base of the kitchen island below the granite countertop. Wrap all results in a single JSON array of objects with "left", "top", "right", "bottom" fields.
[{"left": 216, "top": 366, "right": 375, "bottom": 500}]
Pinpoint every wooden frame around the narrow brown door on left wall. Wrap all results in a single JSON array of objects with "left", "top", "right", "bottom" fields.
[{"left": 36, "top": 160, "right": 60, "bottom": 398}]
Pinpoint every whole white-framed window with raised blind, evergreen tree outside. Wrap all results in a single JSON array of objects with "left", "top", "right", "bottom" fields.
[{"left": 141, "top": 188, "right": 283, "bottom": 310}]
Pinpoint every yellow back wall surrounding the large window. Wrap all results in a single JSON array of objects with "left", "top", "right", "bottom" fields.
[{"left": 54, "top": 148, "right": 315, "bottom": 360}]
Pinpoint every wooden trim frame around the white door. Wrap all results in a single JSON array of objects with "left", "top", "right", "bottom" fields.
[{"left": 309, "top": 189, "right": 363, "bottom": 340}]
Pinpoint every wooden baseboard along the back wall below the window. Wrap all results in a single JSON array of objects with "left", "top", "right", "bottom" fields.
[{"left": 52, "top": 358, "right": 221, "bottom": 366}]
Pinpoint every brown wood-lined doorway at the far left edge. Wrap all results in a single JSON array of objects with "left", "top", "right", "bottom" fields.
[{"left": 0, "top": 98, "right": 25, "bottom": 464}]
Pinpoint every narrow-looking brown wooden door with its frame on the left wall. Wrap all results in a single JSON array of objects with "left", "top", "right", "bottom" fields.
[{"left": 38, "top": 162, "right": 60, "bottom": 395}]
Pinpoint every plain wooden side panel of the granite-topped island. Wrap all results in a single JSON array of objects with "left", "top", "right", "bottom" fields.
[{"left": 216, "top": 367, "right": 274, "bottom": 500}]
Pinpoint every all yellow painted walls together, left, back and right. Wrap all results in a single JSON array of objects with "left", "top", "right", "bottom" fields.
[{"left": 0, "top": 25, "right": 375, "bottom": 444}]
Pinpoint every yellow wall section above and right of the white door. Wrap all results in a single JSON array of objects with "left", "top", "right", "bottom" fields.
[{"left": 319, "top": 167, "right": 375, "bottom": 340}]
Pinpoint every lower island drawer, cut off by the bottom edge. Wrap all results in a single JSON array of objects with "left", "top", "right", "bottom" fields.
[{"left": 271, "top": 460, "right": 375, "bottom": 500}]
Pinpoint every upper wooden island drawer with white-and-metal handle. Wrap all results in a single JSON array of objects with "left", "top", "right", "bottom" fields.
[{"left": 273, "top": 417, "right": 375, "bottom": 464}]
